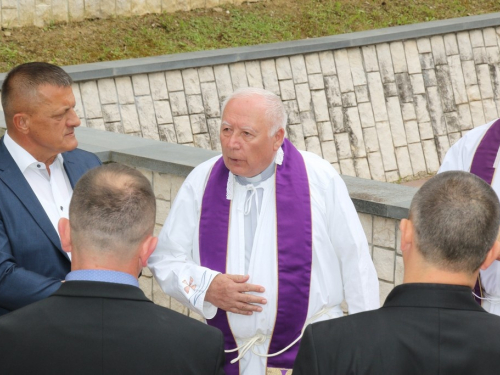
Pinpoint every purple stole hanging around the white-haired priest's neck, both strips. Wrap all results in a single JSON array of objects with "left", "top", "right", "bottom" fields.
[{"left": 199, "top": 139, "right": 312, "bottom": 375}]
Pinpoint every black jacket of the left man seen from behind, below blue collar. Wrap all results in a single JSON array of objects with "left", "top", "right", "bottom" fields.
[{"left": 0, "top": 281, "right": 224, "bottom": 375}]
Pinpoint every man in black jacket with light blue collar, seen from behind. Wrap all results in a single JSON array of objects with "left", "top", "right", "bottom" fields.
[{"left": 0, "top": 164, "right": 224, "bottom": 375}]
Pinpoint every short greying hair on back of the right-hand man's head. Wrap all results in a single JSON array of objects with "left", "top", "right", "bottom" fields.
[{"left": 410, "top": 171, "right": 500, "bottom": 273}]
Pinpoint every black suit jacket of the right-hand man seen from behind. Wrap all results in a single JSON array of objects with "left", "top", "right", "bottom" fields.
[{"left": 293, "top": 284, "right": 500, "bottom": 375}]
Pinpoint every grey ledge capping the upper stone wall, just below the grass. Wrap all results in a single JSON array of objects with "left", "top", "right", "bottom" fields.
[{"left": 0, "top": 13, "right": 500, "bottom": 84}]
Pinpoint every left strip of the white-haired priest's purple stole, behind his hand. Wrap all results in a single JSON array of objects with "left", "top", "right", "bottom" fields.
[{"left": 199, "top": 157, "right": 240, "bottom": 375}]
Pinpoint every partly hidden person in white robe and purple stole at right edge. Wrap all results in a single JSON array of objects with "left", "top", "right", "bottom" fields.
[{"left": 438, "top": 119, "right": 500, "bottom": 315}]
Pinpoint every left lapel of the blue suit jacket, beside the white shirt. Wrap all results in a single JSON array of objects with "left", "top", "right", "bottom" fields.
[{"left": 0, "top": 137, "right": 64, "bottom": 253}]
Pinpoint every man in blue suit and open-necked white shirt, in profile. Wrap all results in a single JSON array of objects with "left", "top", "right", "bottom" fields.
[{"left": 0, "top": 62, "right": 100, "bottom": 315}]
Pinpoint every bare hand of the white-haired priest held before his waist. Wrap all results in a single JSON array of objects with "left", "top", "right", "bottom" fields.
[{"left": 205, "top": 273, "right": 267, "bottom": 315}]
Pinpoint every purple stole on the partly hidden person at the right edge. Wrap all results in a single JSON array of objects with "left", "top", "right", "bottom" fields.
[{"left": 470, "top": 119, "right": 500, "bottom": 304}]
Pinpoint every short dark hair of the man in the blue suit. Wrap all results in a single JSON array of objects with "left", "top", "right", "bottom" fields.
[{"left": 2, "top": 62, "right": 73, "bottom": 124}]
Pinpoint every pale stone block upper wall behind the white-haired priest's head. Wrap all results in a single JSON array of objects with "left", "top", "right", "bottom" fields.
[{"left": 65, "top": 27, "right": 500, "bottom": 182}]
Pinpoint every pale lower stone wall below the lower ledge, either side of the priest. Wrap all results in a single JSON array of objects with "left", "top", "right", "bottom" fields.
[{"left": 134, "top": 168, "right": 403, "bottom": 321}]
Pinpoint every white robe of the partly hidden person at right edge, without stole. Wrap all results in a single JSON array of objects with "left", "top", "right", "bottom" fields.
[{"left": 438, "top": 121, "right": 500, "bottom": 315}]
